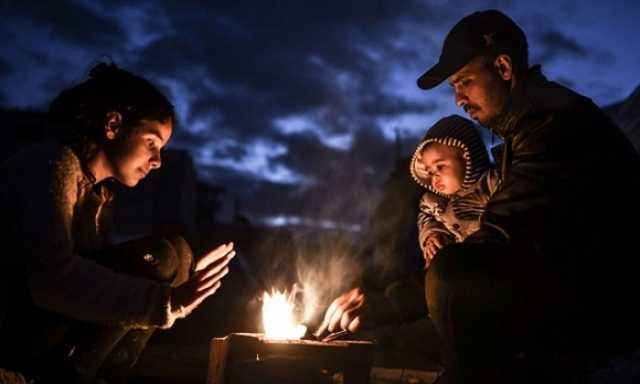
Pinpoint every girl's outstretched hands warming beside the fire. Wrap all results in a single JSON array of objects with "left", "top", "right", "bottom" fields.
[{"left": 171, "top": 243, "right": 236, "bottom": 318}]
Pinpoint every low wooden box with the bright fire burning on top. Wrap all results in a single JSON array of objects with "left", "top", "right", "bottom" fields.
[{"left": 207, "top": 288, "right": 373, "bottom": 384}]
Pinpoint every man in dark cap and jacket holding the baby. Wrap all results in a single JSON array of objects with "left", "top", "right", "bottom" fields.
[{"left": 327, "top": 10, "right": 640, "bottom": 383}]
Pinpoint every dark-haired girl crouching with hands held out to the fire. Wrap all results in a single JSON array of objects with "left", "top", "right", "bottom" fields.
[{"left": 0, "top": 64, "right": 235, "bottom": 382}]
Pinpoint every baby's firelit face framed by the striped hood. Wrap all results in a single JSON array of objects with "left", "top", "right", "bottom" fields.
[{"left": 422, "top": 143, "right": 466, "bottom": 195}]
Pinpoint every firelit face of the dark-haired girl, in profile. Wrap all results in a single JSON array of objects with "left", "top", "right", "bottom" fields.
[{"left": 105, "top": 119, "right": 173, "bottom": 187}]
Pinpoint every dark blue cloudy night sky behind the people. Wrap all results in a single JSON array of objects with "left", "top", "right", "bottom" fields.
[{"left": 0, "top": 0, "right": 640, "bottom": 229}]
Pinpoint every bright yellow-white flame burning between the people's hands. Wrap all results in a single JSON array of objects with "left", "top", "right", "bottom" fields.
[{"left": 262, "top": 292, "right": 307, "bottom": 340}]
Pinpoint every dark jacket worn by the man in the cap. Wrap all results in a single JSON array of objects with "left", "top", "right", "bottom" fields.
[{"left": 467, "top": 66, "right": 640, "bottom": 317}]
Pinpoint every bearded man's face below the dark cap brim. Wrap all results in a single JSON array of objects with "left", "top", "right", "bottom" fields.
[{"left": 448, "top": 57, "right": 510, "bottom": 125}]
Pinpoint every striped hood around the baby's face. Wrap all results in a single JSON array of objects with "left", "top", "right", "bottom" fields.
[{"left": 410, "top": 115, "right": 489, "bottom": 196}]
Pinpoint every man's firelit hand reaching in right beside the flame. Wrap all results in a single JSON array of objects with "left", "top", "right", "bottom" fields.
[{"left": 315, "top": 288, "right": 365, "bottom": 336}]
